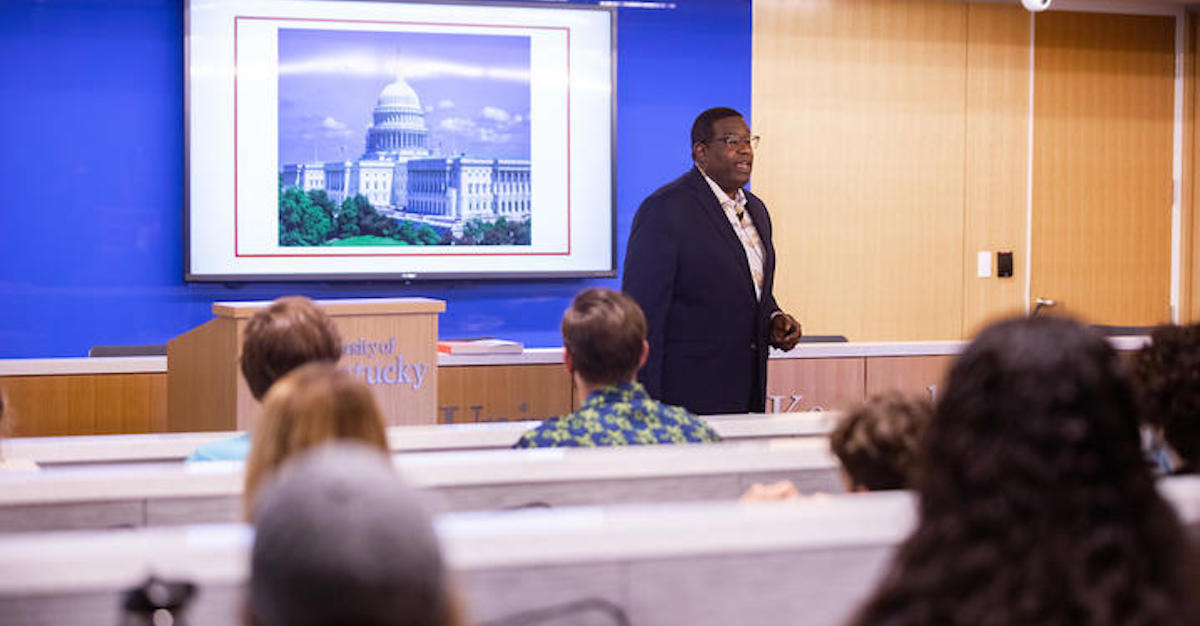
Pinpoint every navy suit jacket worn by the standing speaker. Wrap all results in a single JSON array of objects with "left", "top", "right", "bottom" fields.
[{"left": 622, "top": 168, "right": 779, "bottom": 414}]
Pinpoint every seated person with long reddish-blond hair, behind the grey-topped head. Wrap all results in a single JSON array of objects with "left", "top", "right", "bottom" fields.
[{"left": 242, "top": 363, "right": 390, "bottom": 517}]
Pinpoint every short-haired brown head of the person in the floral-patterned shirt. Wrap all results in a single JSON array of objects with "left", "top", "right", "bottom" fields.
[{"left": 563, "top": 288, "right": 646, "bottom": 385}]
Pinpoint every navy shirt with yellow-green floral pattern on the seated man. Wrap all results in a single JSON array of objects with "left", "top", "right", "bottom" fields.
[{"left": 512, "top": 383, "right": 721, "bottom": 447}]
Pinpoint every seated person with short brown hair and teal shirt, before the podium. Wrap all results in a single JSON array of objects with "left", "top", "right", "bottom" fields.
[{"left": 187, "top": 296, "right": 342, "bottom": 462}]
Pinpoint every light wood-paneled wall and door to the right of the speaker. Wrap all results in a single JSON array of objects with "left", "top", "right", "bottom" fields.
[{"left": 751, "top": 0, "right": 1185, "bottom": 341}]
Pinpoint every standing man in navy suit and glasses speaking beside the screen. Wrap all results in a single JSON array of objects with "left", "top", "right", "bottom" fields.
[{"left": 622, "top": 108, "right": 800, "bottom": 414}]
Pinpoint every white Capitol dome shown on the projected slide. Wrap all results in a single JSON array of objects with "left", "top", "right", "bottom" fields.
[{"left": 362, "top": 77, "right": 430, "bottom": 159}]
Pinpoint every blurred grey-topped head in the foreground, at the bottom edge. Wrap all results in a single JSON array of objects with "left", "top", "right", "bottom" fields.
[{"left": 248, "top": 444, "right": 452, "bottom": 626}]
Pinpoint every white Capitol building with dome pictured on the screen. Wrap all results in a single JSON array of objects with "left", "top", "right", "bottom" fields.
[{"left": 281, "top": 78, "right": 530, "bottom": 235}]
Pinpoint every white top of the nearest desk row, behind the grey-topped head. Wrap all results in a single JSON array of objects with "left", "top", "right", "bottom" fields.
[{"left": 0, "top": 492, "right": 914, "bottom": 596}]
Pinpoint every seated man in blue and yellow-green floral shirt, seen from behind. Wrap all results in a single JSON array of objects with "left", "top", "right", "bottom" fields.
[{"left": 512, "top": 288, "right": 720, "bottom": 447}]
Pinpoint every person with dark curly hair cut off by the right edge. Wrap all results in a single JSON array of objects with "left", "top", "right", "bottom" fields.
[{"left": 1132, "top": 325, "right": 1200, "bottom": 474}]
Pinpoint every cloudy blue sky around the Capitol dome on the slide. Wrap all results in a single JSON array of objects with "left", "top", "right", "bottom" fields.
[{"left": 278, "top": 29, "right": 529, "bottom": 167}]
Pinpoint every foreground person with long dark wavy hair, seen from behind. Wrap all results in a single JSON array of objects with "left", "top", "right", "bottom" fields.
[{"left": 852, "top": 318, "right": 1196, "bottom": 626}]
